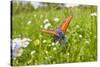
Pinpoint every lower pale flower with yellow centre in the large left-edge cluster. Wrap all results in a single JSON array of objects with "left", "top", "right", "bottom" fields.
[{"left": 12, "top": 43, "right": 23, "bottom": 57}]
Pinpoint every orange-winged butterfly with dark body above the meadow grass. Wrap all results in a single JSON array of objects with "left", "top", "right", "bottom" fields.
[{"left": 42, "top": 16, "right": 72, "bottom": 44}]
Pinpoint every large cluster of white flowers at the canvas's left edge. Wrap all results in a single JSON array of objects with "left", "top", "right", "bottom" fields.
[{"left": 11, "top": 38, "right": 31, "bottom": 57}]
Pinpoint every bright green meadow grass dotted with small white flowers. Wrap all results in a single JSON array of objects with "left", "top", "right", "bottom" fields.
[{"left": 12, "top": 3, "right": 97, "bottom": 66}]
